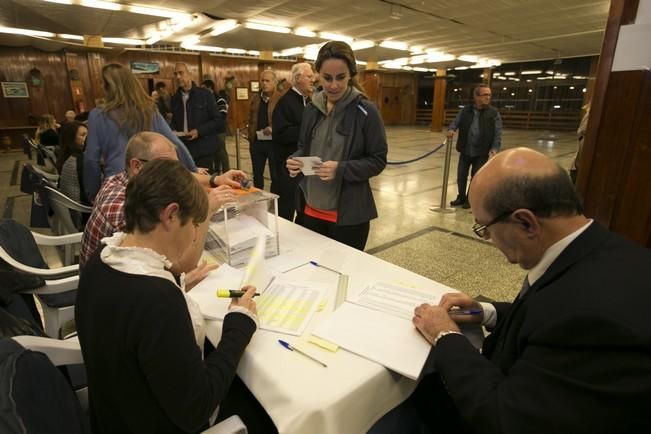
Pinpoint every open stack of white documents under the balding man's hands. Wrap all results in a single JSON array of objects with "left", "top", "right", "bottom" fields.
[{"left": 313, "top": 283, "right": 439, "bottom": 380}]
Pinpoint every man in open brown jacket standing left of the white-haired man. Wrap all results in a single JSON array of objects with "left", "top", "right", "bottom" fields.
[{"left": 248, "top": 69, "right": 280, "bottom": 189}]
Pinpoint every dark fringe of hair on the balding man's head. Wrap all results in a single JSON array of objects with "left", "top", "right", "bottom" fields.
[{"left": 484, "top": 165, "right": 583, "bottom": 217}]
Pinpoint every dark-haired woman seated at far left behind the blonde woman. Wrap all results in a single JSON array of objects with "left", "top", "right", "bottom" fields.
[{"left": 57, "top": 120, "right": 89, "bottom": 205}]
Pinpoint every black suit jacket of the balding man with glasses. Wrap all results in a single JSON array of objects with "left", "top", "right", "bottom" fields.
[{"left": 434, "top": 222, "right": 651, "bottom": 434}]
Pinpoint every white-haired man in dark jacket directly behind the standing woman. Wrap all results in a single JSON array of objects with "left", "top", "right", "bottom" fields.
[{"left": 270, "top": 63, "right": 314, "bottom": 221}]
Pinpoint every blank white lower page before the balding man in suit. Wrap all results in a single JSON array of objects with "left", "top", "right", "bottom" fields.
[{"left": 313, "top": 303, "right": 431, "bottom": 380}]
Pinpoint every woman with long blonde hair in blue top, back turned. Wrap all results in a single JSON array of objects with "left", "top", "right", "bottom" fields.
[{"left": 84, "top": 63, "right": 197, "bottom": 201}]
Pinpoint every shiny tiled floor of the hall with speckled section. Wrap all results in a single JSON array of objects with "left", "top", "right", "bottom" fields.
[{"left": 0, "top": 127, "right": 576, "bottom": 300}]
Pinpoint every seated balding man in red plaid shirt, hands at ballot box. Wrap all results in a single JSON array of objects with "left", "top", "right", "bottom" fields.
[{"left": 79, "top": 131, "right": 246, "bottom": 272}]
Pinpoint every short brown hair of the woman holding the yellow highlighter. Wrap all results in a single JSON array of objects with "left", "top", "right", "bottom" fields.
[{"left": 124, "top": 159, "right": 208, "bottom": 234}]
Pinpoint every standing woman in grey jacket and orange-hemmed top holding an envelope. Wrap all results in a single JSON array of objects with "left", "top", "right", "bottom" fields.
[{"left": 287, "top": 41, "right": 387, "bottom": 250}]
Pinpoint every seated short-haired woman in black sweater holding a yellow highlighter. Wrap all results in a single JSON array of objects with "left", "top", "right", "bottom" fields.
[{"left": 75, "top": 159, "right": 257, "bottom": 434}]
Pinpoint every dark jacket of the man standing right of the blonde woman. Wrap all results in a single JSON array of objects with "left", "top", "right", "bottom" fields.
[{"left": 172, "top": 83, "right": 226, "bottom": 160}]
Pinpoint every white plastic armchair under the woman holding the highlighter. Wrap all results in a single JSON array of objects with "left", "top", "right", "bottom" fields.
[{"left": 12, "top": 336, "right": 247, "bottom": 434}]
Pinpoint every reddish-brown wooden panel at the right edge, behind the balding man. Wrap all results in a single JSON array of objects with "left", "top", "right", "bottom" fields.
[{"left": 607, "top": 71, "right": 651, "bottom": 247}]
